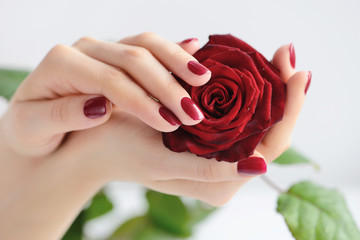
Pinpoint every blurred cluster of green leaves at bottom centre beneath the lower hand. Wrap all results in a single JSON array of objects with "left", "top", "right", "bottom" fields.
[{"left": 111, "top": 190, "right": 216, "bottom": 240}]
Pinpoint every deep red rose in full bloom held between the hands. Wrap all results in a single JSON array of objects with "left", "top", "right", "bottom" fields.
[{"left": 163, "top": 35, "right": 286, "bottom": 162}]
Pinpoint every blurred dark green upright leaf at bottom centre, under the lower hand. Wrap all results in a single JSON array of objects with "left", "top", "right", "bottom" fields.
[{"left": 146, "top": 190, "right": 191, "bottom": 237}]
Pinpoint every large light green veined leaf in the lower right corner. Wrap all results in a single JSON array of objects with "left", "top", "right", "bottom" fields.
[{"left": 277, "top": 182, "right": 360, "bottom": 240}]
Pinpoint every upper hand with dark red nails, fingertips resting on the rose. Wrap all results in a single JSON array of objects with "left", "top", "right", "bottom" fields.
[{"left": 0, "top": 33, "right": 211, "bottom": 156}]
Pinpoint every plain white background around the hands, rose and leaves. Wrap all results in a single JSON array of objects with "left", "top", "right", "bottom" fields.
[{"left": 0, "top": 0, "right": 360, "bottom": 239}]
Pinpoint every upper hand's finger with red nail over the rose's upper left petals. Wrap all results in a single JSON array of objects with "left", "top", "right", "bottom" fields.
[{"left": 120, "top": 33, "right": 211, "bottom": 86}]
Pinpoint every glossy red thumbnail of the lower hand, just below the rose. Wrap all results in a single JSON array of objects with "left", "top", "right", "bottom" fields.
[{"left": 237, "top": 157, "right": 267, "bottom": 176}]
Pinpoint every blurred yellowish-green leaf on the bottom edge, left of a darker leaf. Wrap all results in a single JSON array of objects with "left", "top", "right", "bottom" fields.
[{"left": 109, "top": 215, "right": 178, "bottom": 240}]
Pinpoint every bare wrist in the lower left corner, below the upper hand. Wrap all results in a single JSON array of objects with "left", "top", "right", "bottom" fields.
[{"left": 0, "top": 142, "right": 102, "bottom": 239}]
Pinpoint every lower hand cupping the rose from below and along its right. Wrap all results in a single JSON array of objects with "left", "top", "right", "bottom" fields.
[{"left": 64, "top": 42, "right": 311, "bottom": 205}]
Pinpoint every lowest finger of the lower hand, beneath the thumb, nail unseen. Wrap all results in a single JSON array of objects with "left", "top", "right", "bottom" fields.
[{"left": 145, "top": 180, "right": 243, "bottom": 206}]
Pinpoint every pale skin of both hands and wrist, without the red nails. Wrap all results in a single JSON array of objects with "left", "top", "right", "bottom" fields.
[{"left": 0, "top": 33, "right": 308, "bottom": 239}]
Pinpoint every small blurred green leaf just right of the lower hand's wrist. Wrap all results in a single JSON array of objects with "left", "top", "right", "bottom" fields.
[{"left": 85, "top": 191, "right": 113, "bottom": 222}]
